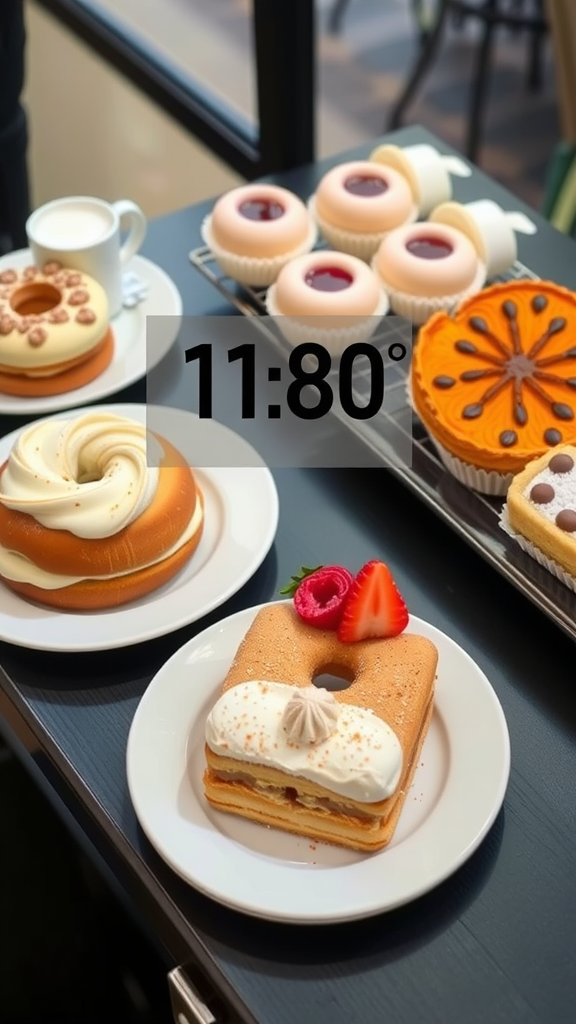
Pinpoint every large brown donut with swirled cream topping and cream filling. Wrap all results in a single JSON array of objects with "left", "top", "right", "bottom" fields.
[{"left": 0, "top": 410, "right": 204, "bottom": 609}]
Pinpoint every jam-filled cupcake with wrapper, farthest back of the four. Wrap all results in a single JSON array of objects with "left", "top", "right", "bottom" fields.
[{"left": 308, "top": 160, "right": 418, "bottom": 262}]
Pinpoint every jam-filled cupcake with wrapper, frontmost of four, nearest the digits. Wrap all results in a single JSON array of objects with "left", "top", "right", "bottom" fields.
[{"left": 266, "top": 251, "right": 388, "bottom": 357}]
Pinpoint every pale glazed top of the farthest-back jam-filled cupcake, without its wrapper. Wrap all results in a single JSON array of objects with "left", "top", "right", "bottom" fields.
[{"left": 315, "top": 160, "right": 416, "bottom": 234}]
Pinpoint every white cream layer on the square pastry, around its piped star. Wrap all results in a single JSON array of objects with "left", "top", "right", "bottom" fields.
[{"left": 205, "top": 680, "right": 403, "bottom": 804}]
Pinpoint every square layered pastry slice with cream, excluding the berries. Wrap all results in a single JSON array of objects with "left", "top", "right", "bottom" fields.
[{"left": 204, "top": 589, "right": 438, "bottom": 852}]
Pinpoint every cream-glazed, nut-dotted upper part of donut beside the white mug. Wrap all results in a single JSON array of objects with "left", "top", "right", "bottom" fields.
[{"left": 0, "top": 261, "right": 109, "bottom": 374}]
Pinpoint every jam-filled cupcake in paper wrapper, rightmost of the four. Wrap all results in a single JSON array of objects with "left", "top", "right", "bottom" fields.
[{"left": 372, "top": 221, "right": 486, "bottom": 326}]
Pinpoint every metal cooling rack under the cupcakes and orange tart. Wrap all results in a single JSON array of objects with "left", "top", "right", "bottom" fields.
[{"left": 190, "top": 247, "right": 576, "bottom": 640}]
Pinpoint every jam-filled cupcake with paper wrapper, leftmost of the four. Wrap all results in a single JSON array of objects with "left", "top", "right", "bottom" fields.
[{"left": 202, "top": 184, "right": 318, "bottom": 288}]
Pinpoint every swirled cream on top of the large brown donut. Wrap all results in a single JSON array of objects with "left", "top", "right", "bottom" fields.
[{"left": 0, "top": 412, "right": 158, "bottom": 540}]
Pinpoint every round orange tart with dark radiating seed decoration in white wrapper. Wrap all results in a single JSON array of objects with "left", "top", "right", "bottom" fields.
[{"left": 411, "top": 281, "right": 576, "bottom": 495}]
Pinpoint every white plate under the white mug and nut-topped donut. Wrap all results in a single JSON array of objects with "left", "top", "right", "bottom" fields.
[{"left": 0, "top": 249, "right": 182, "bottom": 416}]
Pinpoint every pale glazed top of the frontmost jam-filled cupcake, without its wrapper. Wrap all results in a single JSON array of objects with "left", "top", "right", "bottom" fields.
[{"left": 274, "top": 251, "right": 381, "bottom": 317}]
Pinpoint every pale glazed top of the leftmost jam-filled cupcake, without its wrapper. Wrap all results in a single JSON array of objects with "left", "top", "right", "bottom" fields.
[{"left": 209, "top": 184, "right": 314, "bottom": 259}]
